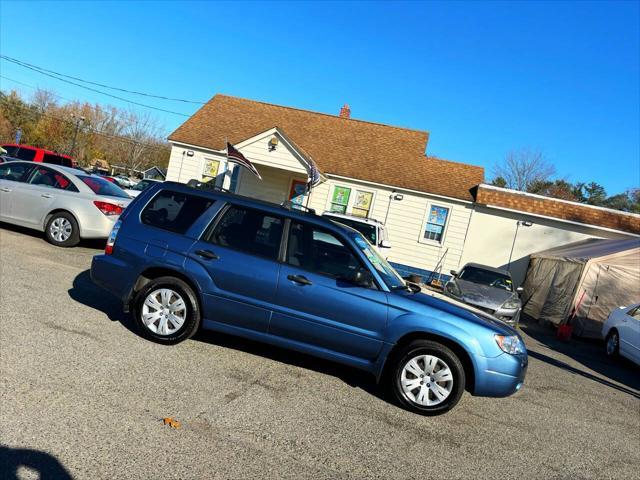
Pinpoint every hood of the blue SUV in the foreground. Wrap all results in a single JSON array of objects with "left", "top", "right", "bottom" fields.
[{"left": 394, "top": 290, "right": 517, "bottom": 335}]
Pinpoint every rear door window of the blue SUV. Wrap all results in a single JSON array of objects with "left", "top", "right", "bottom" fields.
[{"left": 205, "top": 205, "right": 283, "bottom": 260}]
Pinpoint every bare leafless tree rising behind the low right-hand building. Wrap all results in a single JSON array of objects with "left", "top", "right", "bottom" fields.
[{"left": 493, "top": 148, "right": 556, "bottom": 191}]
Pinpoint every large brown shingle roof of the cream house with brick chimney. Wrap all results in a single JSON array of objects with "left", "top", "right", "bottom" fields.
[{"left": 169, "top": 95, "right": 484, "bottom": 200}]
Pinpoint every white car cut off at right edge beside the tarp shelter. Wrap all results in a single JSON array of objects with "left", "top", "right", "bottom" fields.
[{"left": 602, "top": 303, "right": 640, "bottom": 365}]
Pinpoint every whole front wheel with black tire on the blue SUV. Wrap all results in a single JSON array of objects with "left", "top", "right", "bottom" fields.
[{"left": 387, "top": 340, "right": 466, "bottom": 415}]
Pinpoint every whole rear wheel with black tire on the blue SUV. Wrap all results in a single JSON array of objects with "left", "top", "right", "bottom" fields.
[{"left": 133, "top": 277, "right": 201, "bottom": 345}]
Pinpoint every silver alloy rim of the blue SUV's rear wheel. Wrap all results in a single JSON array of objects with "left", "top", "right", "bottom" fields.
[{"left": 142, "top": 288, "right": 187, "bottom": 336}]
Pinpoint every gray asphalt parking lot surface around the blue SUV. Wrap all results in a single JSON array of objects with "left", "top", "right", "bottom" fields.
[{"left": 0, "top": 225, "right": 640, "bottom": 479}]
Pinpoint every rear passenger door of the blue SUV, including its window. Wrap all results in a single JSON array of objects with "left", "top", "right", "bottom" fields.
[{"left": 189, "top": 205, "right": 283, "bottom": 333}]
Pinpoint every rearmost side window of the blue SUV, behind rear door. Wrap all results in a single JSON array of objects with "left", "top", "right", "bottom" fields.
[{"left": 140, "top": 190, "right": 214, "bottom": 234}]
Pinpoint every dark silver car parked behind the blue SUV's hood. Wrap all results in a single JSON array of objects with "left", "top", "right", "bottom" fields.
[{"left": 444, "top": 263, "right": 522, "bottom": 326}]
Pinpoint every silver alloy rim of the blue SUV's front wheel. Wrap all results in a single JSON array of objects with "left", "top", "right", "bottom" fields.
[{"left": 400, "top": 355, "right": 453, "bottom": 407}]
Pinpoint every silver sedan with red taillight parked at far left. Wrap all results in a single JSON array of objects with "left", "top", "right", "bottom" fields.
[{"left": 0, "top": 161, "right": 131, "bottom": 247}]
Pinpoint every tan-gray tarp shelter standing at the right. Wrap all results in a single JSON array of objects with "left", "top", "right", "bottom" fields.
[{"left": 523, "top": 238, "right": 640, "bottom": 338}]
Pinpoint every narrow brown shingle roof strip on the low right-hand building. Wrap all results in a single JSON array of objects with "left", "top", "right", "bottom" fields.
[{"left": 475, "top": 185, "right": 640, "bottom": 234}]
